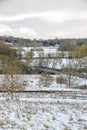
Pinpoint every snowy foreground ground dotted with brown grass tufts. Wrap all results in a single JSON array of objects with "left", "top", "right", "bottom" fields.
[{"left": 0, "top": 99, "right": 87, "bottom": 130}]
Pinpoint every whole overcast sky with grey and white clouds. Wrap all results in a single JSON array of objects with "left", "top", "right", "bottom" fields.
[{"left": 0, "top": 0, "right": 87, "bottom": 39}]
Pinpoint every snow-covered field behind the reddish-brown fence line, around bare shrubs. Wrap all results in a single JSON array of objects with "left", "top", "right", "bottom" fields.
[{"left": 0, "top": 74, "right": 87, "bottom": 91}]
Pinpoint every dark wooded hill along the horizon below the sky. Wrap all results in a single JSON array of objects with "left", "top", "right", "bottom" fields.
[{"left": 0, "top": 36, "right": 87, "bottom": 46}]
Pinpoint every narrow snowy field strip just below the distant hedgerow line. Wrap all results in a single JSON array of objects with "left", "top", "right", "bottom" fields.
[{"left": 25, "top": 58, "right": 87, "bottom": 69}]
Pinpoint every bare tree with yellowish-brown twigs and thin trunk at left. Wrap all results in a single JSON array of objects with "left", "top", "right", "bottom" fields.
[{"left": 3, "top": 57, "right": 24, "bottom": 99}]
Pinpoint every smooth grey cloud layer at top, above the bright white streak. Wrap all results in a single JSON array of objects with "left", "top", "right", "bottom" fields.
[{"left": 0, "top": 0, "right": 87, "bottom": 15}]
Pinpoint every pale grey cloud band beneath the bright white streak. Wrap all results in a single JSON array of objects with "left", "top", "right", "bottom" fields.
[{"left": 2, "top": 14, "right": 87, "bottom": 38}]
